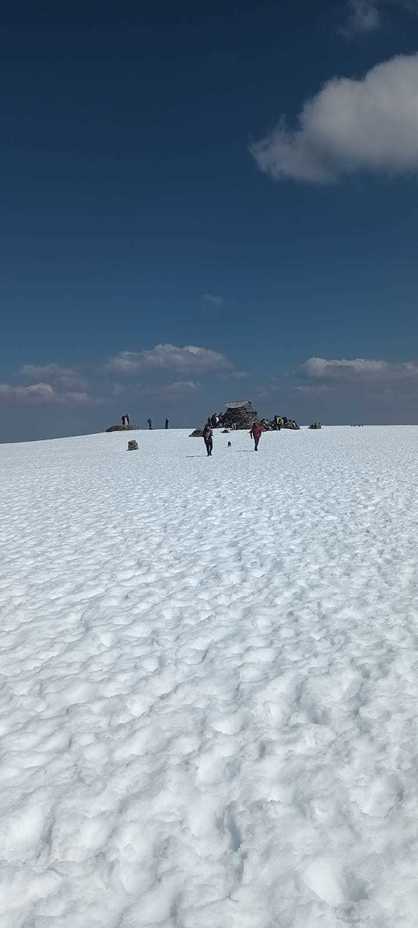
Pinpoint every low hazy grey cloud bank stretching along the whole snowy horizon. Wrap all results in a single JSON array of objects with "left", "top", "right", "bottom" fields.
[{"left": 0, "top": 346, "right": 418, "bottom": 441}]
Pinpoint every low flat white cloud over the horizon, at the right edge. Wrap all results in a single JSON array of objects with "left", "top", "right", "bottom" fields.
[{"left": 300, "top": 358, "right": 418, "bottom": 385}]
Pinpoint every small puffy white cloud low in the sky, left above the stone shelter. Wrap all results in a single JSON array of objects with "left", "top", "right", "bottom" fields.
[{"left": 109, "top": 345, "right": 232, "bottom": 374}]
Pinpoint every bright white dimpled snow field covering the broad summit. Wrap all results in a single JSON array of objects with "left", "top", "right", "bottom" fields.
[{"left": 0, "top": 427, "right": 418, "bottom": 928}]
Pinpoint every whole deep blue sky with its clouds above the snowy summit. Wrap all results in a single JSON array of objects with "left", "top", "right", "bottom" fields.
[{"left": 0, "top": 0, "right": 418, "bottom": 441}]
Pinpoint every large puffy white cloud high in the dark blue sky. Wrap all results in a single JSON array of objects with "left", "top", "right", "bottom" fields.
[{"left": 251, "top": 54, "right": 418, "bottom": 183}]
